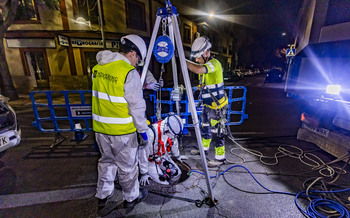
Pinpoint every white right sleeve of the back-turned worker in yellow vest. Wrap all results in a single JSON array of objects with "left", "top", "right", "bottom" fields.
[{"left": 124, "top": 70, "right": 148, "bottom": 133}]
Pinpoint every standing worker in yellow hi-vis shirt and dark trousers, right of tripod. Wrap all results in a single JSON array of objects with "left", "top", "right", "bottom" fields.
[{"left": 186, "top": 36, "right": 228, "bottom": 167}]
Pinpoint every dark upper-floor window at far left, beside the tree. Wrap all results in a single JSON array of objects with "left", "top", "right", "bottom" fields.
[{"left": 15, "top": 0, "right": 39, "bottom": 22}]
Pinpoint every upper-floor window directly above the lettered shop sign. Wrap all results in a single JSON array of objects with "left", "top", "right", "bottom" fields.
[{"left": 73, "top": 0, "right": 103, "bottom": 24}]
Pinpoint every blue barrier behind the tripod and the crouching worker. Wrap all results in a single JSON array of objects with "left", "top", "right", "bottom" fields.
[{"left": 150, "top": 86, "right": 248, "bottom": 127}]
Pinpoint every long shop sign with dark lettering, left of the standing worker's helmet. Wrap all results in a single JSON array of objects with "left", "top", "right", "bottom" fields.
[{"left": 71, "top": 38, "right": 120, "bottom": 49}]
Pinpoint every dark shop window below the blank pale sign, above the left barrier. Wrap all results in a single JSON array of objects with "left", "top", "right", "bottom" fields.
[{"left": 21, "top": 49, "right": 50, "bottom": 88}]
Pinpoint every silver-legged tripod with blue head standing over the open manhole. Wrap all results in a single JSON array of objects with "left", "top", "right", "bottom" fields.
[{"left": 141, "top": 0, "right": 216, "bottom": 205}]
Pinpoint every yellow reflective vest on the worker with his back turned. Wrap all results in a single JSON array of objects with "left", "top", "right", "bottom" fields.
[{"left": 92, "top": 60, "right": 136, "bottom": 135}]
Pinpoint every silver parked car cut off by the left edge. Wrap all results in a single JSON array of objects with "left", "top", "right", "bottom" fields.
[{"left": 0, "top": 95, "right": 21, "bottom": 156}]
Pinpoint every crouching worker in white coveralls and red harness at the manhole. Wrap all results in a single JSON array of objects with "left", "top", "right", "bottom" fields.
[{"left": 139, "top": 113, "right": 184, "bottom": 185}]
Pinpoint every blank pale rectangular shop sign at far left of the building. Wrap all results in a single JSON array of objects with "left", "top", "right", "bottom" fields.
[{"left": 6, "top": 38, "right": 56, "bottom": 48}]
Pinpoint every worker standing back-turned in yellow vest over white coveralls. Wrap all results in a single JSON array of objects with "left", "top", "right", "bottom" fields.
[{"left": 92, "top": 35, "right": 148, "bottom": 215}]
